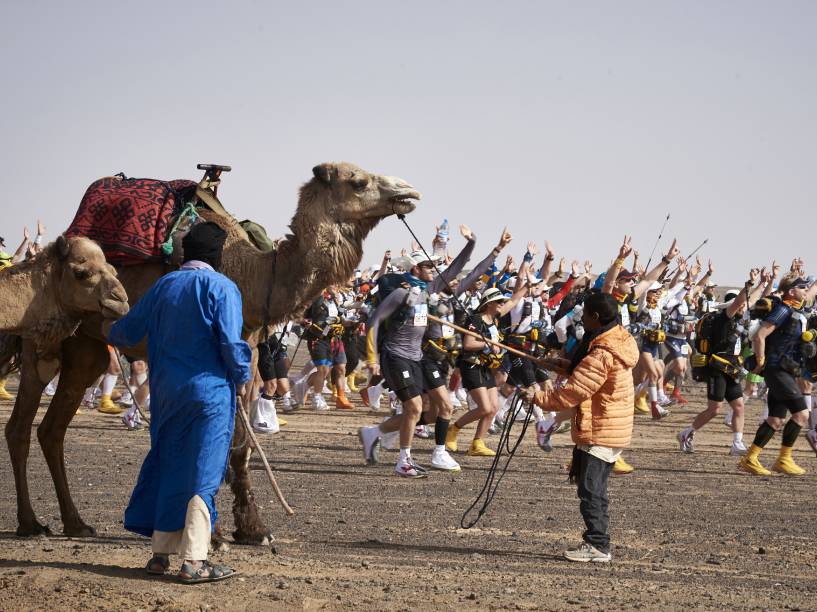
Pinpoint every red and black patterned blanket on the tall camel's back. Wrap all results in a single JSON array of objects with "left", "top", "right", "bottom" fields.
[{"left": 65, "top": 175, "right": 197, "bottom": 265}]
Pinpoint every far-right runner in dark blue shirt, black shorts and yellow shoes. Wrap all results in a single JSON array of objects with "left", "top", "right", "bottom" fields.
[{"left": 738, "top": 264, "right": 817, "bottom": 476}]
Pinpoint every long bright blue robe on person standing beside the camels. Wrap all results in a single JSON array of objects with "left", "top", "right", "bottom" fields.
[{"left": 109, "top": 269, "right": 252, "bottom": 536}]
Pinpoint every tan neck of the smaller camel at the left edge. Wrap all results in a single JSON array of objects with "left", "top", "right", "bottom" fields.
[{"left": 0, "top": 264, "right": 77, "bottom": 344}]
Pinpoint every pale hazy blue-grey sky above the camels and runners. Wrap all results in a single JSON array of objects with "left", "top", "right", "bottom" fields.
[{"left": 0, "top": 0, "right": 817, "bottom": 283}]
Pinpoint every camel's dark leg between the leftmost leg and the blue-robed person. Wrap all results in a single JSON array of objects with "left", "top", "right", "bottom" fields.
[{"left": 37, "top": 336, "right": 108, "bottom": 537}]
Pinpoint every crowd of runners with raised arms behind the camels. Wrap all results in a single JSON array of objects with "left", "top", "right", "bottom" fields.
[{"left": 7, "top": 221, "right": 817, "bottom": 478}]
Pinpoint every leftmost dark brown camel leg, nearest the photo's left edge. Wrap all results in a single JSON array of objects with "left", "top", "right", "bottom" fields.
[{"left": 6, "top": 341, "right": 51, "bottom": 536}]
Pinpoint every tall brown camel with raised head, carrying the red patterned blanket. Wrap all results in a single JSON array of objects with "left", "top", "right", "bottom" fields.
[{"left": 6, "top": 162, "right": 421, "bottom": 544}]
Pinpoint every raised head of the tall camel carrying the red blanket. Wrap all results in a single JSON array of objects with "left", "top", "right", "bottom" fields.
[{"left": 301, "top": 162, "right": 421, "bottom": 227}]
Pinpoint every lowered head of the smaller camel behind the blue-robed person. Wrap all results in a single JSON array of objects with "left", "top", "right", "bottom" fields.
[{"left": 54, "top": 236, "right": 128, "bottom": 319}]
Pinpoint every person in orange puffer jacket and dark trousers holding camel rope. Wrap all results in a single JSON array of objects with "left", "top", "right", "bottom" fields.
[{"left": 533, "top": 293, "right": 638, "bottom": 563}]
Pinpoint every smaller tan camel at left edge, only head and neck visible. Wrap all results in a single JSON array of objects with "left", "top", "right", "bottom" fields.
[{"left": 0, "top": 236, "right": 128, "bottom": 361}]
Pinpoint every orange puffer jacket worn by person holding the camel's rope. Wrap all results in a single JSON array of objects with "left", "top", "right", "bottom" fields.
[{"left": 534, "top": 325, "right": 638, "bottom": 448}]
